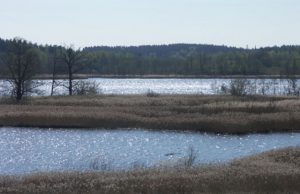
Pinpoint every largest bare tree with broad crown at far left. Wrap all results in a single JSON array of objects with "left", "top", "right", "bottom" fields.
[{"left": 3, "top": 38, "right": 40, "bottom": 102}]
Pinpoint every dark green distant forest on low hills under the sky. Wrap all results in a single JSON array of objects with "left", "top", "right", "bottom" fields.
[{"left": 0, "top": 39, "right": 300, "bottom": 75}]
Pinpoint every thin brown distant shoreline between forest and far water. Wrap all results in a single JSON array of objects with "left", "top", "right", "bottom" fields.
[{"left": 0, "top": 74, "right": 300, "bottom": 79}]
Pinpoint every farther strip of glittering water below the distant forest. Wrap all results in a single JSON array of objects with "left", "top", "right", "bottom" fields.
[{"left": 0, "top": 78, "right": 300, "bottom": 96}]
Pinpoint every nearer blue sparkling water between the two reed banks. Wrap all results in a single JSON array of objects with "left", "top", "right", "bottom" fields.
[{"left": 0, "top": 127, "right": 300, "bottom": 175}]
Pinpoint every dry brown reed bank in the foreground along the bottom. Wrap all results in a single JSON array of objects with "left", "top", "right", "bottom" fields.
[{"left": 0, "top": 148, "right": 300, "bottom": 194}]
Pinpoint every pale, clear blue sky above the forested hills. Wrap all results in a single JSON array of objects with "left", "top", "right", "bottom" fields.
[{"left": 0, "top": 0, "right": 300, "bottom": 48}]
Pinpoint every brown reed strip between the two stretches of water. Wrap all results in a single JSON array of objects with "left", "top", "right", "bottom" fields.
[{"left": 0, "top": 95, "right": 300, "bottom": 133}]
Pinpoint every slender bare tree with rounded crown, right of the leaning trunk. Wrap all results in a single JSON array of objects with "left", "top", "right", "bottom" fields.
[{"left": 62, "top": 46, "right": 82, "bottom": 96}]
